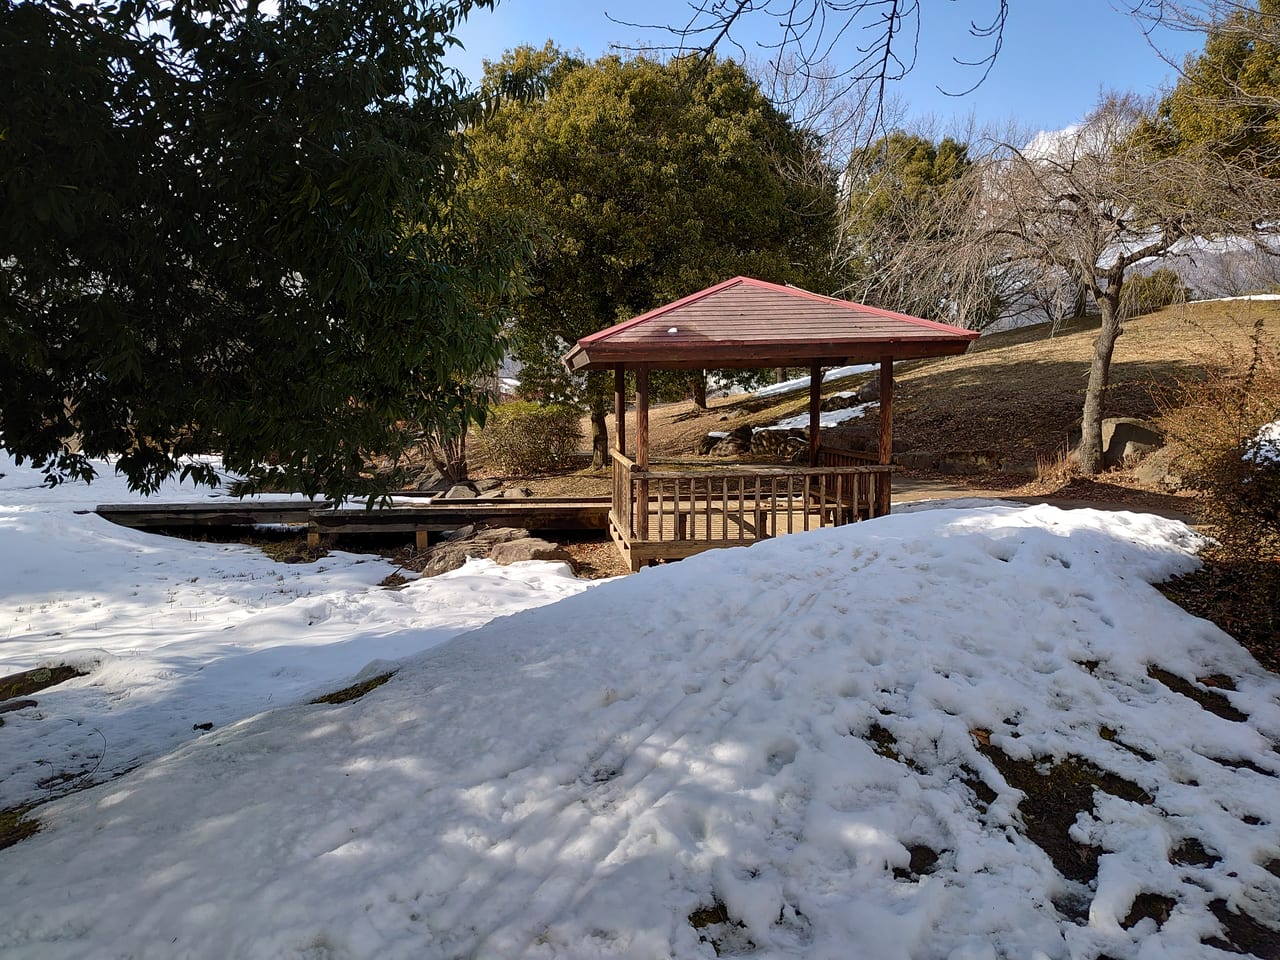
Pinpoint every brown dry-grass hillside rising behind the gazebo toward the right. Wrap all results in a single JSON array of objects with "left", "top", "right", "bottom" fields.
[{"left": 486, "top": 301, "right": 1280, "bottom": 494}]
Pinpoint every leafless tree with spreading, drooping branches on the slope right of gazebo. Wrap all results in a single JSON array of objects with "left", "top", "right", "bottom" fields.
[{"left": 980, "top": 96, "right": 1277, "bottom": 474}]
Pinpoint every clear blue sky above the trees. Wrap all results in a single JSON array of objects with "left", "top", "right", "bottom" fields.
[{"left": 451, "top": 0, "right": 1202, "bottom": 129}]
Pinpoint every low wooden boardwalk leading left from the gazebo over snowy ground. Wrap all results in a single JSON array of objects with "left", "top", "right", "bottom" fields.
[{"left": 93, "top": 497, "right": 609, "bottom": 549}]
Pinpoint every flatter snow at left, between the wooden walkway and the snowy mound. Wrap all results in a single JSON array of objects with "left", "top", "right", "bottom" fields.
[{"left": 0, "top": 454, "right": 599, "bottom": 809}]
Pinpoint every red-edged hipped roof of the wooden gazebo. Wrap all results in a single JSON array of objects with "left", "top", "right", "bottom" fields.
[{"left": 564, "top": 276, "right": 978, "bottom": 371}]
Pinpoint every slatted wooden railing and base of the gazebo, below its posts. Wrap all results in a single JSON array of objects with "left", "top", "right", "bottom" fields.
[{"left": 609, "top": 451, "right": 893, "bottom": 570}]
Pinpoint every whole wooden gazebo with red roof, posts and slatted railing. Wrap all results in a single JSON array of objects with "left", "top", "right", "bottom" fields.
[{"left": 564, "top": 276, "right": 978, "bottom": 570}]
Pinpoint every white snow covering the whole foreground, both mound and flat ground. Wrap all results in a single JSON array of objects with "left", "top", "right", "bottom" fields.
[{"left": 0, "top": 453, "right": 1280, "bottom": 960}]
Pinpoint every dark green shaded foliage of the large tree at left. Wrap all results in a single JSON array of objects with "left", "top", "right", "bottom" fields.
[{"left": 0, "top": 0, "right": 521, "bottom": 497}]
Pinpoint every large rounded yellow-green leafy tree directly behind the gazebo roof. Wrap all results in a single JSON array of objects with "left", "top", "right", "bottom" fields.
[{"left": 471, "top": 47, "right": 835, "bottom": 465}]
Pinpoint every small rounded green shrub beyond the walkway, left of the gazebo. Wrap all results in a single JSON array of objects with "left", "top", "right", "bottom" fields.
[{"left": 475, "top": 401, "right": 582, "bottom": 475}]
